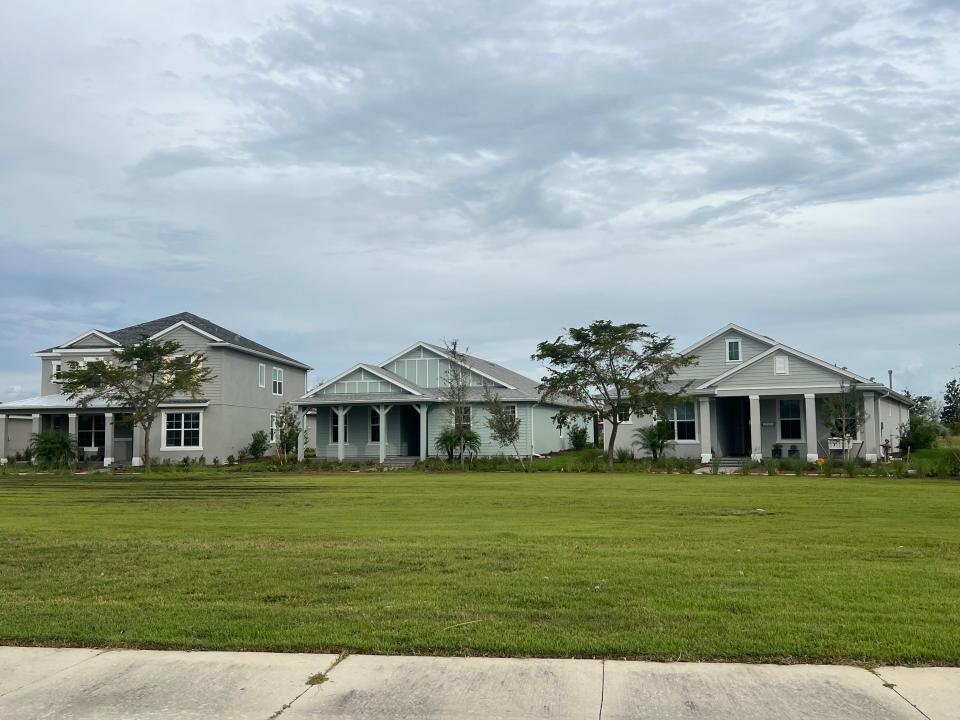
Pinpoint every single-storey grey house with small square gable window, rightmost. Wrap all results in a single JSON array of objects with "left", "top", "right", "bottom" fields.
[{"left": 604, "top": 324, "right": 910, "bottom": 463}]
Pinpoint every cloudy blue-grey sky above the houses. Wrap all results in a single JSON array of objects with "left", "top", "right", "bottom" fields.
[{"left": 0, "top": 0, "right": 960, "bottom": 402}]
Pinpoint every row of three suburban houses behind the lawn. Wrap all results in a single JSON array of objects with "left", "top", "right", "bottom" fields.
[{"left": 0, "top": 313, "right": 910, "bottom": 466}]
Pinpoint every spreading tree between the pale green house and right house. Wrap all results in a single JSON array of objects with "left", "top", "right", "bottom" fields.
[{"left": 532, "top": 320, "right": 696, "bottom": 470}]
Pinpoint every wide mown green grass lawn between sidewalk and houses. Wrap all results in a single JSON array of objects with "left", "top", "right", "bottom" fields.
[{"left": 0, "top": 473, "right": 960, "bottom": 664}]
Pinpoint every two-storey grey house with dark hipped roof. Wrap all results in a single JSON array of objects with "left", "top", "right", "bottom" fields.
[{"left": 0, "top": 312, "right": 310, "bottom": 466}]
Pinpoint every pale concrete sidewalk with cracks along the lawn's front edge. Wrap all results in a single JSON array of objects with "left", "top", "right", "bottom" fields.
[{"left": 0, "top": 647, "right": 960, "bottom": 720}]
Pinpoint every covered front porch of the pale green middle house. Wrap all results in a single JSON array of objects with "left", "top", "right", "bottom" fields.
[{"left": 296, "top": 395, "right": 430, "bottom": 464}]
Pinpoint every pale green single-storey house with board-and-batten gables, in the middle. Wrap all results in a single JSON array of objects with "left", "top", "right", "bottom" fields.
[{"left": 297, "top": 342, "right": 592, "bottom": 463}]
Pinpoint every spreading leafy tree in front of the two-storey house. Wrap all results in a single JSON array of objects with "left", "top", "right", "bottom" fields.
[{"left": 60, "top": 335, "right": 214, "bottom": 472}]
